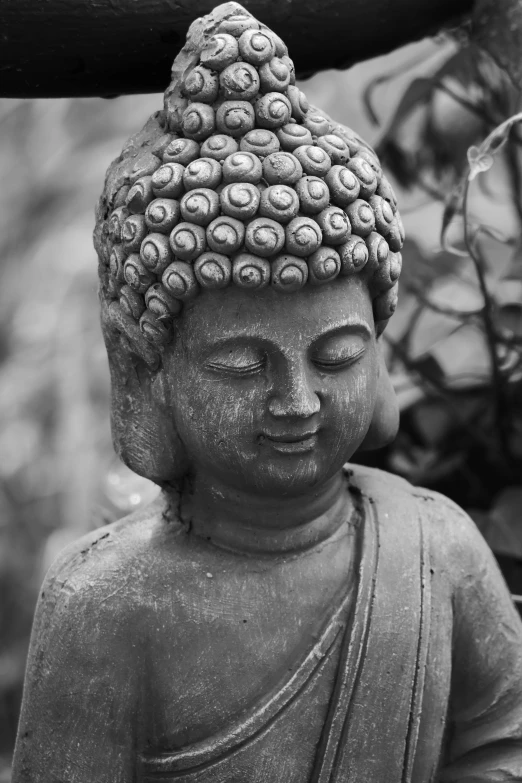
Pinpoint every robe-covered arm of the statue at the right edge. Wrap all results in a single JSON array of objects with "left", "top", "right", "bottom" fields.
[{"left": 432, "top": 501, "right": 522, "bottom": 783}]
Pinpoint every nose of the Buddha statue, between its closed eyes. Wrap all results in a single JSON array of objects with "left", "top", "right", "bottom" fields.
[{"left": 268, "top": 365, "right": 321, "bottom": 419}]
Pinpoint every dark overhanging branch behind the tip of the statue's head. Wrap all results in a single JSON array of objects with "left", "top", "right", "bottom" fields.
[{"left": 0, "top": 0, "right": 474, "bottom": 98}]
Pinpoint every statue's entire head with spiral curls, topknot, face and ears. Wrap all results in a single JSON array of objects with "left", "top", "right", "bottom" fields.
[{"left": 95, "top": 3, "right": 404, "bottom": 494}]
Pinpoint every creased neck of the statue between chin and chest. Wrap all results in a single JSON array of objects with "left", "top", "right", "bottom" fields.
[{"left": 168, "top": 472, "right": 353, "bottom": 554}]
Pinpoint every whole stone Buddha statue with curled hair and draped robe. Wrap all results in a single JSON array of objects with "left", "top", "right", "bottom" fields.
[{"left": 13, "top": 3, "right": 522, "bottom": 783}]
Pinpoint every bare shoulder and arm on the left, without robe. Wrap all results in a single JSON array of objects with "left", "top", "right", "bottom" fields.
[{"left": 13, "top": 504, "right": 182, "bottom": 783}]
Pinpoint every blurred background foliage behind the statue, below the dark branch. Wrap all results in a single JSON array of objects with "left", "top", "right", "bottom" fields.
[{"left": 0, "top": 29, "right": 522, "bottom": 783}]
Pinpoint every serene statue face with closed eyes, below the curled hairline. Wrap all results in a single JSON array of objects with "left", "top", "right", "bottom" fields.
[{"left": 162, "top": 277, "right": 377, "bottom": 496}]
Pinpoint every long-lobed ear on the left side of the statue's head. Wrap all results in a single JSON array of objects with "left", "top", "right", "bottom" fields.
[{"left": 102, "top": 303, "right": 188, "bottom": 484}]
